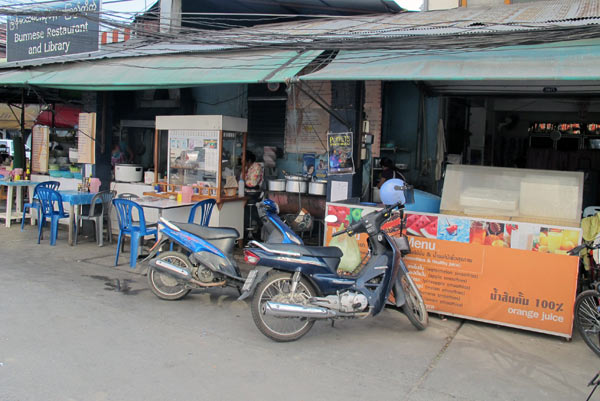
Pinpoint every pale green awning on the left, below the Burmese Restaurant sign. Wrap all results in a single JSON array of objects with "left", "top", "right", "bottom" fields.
[{"left": 0, "top": 50, "right": 321, "bottom": 91}]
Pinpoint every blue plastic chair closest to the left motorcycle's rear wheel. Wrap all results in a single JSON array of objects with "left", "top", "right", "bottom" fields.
[{"left": 112, "top": 198, "right": 157, "bottom": 268}]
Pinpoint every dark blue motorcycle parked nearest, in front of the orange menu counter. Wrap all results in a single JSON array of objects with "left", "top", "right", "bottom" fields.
[{"left": 239, "top": 179, "right": 428, "bottom": 341}]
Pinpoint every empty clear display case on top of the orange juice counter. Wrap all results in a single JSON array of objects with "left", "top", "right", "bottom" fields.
[{"left": 440, "top": 165, "right": 583, "bottom": 227}]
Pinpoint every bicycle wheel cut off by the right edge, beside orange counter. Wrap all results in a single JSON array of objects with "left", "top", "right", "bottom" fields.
[{"left": 575, "top": 290, "right": 600, "bottom": 356}]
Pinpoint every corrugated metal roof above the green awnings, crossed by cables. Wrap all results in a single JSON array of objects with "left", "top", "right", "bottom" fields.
[{"left": 0, "top": 0, "right": 600, "bottom": 68}]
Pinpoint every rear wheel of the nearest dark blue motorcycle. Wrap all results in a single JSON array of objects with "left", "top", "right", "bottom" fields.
[{"left": 250, "top": 273, "right": 316, "bottom": 342}]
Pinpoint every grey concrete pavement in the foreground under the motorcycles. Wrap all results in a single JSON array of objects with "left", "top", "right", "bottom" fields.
[{"left": 0, "top": 225, "right": 600, "bottom": 401}]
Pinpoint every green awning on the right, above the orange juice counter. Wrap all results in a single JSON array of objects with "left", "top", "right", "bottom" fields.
[{"left": 300, "top": 39, "right": 600, "bottom": 81}]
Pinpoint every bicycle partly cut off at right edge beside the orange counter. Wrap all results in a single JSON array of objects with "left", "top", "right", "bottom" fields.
[{"left": 569, "top": 242, "right": 600, "bottom": 356}]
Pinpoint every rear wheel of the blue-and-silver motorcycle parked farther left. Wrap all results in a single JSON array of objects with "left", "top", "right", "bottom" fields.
[{"left": 148, "top": 251, "right": 192, "bottom": 301}]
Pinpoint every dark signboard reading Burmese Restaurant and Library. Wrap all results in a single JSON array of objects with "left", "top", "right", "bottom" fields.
[{"left": 6, "top": 0, "right": 100, "bottom": 62}]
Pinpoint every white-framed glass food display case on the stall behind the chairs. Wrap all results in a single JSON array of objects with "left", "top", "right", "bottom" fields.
[{"left": 155, "top": 116, "right": 247, "bottom": 199}]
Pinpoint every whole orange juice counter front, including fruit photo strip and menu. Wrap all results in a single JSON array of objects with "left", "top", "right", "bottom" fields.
[{"left": 325, "top": 203, "right": 581, "bottom": 337}]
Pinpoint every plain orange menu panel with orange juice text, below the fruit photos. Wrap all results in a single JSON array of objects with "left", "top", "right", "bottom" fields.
[{"left": 404, "top": 236, "right": 579, "bottom": 337}]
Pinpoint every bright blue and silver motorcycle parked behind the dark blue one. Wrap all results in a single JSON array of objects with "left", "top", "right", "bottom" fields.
[{"left": 145, "top": 199, "right": 303, "bottom": 300}]
